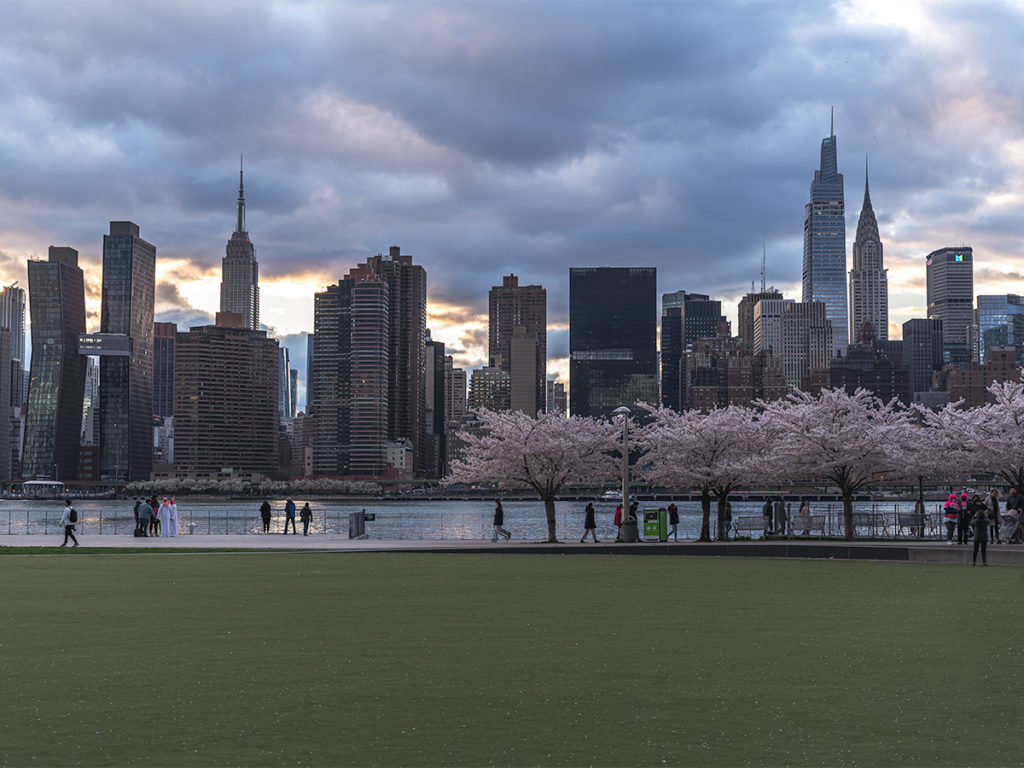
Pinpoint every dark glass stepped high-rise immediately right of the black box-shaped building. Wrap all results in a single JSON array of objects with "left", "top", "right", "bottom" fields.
[{"left": 662, "top": 291, "right": 725, "bottom": 411}]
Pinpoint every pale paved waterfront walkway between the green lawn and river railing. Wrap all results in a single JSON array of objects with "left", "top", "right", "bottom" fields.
[{"left": 0, "top": 534, "right": 1024, "bottom": 565}]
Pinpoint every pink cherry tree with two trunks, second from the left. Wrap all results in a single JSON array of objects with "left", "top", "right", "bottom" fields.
[{"left": 640, "top": 403, "right": 757, "bottom": 542}]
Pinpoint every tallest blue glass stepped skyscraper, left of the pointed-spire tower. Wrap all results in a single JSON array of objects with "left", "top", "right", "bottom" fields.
[{"left": 802, "top": 115, "right": 850, "bottom": 357}]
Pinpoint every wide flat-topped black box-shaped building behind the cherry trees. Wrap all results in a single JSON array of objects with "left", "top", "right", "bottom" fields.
[{"left": 569, "top": 266, "right": 658, "bottom": 417}]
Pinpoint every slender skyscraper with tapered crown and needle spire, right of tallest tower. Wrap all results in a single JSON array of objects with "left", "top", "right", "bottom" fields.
[{"left": 850, "top": 160, "right": 889, "bottom": 341}]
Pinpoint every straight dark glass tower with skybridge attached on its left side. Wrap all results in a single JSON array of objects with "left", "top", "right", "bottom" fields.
[{"left": 92, "top": 221, "right": 157, "bottom": 481}]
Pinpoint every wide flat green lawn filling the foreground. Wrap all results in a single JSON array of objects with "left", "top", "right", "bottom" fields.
[{"left": 0, "top": 553, "right": 1024, "bottom": 766}]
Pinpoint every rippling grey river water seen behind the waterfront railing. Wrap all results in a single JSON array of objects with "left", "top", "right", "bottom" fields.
[{"left": 0, "top": 499, "right": 940, "bottom": 545}]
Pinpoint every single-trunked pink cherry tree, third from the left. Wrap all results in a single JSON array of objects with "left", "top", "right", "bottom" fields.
[{"left": 758, "top": 388, "right": 909, "bottom": 540}]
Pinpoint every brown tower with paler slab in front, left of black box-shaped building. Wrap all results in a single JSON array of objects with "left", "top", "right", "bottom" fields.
[{"left": 487, "top": 274, "right": 548, "bottom": 416}]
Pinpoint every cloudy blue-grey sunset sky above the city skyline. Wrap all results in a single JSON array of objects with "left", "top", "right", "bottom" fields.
[{"left": 0, "top": 0, "right": 1024, "bottom": 409}]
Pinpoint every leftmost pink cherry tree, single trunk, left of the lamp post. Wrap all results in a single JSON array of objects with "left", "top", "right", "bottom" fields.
[{"left": 446, "top": 410, "right": 622, "bottom": 543}]
